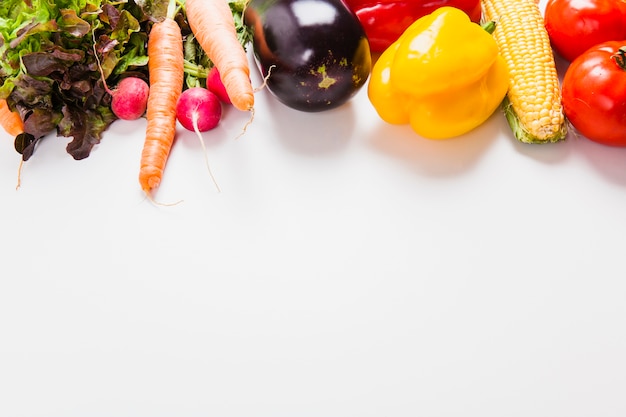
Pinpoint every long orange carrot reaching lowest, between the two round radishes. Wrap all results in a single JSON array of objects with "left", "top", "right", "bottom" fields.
[{"left": 139, "top": 17, "right": 184, "bottom": 194}]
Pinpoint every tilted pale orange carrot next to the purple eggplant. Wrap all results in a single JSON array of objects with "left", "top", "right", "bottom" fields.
[{"left": 185, "top": 0, "right": 254, "bottom": 111}]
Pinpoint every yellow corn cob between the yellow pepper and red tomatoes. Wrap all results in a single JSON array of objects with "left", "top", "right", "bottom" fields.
[{"left": 481, "top": 0, "right": 567, "bottom": 143}]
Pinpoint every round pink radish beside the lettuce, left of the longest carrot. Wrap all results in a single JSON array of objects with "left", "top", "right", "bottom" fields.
[{"left": 111, "top": 77, "right": 150, "bottom": 120}]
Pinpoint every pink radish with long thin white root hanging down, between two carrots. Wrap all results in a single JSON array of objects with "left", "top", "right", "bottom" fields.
[{"left": 176, "top": 87, "right": 222, "bottom": 132}]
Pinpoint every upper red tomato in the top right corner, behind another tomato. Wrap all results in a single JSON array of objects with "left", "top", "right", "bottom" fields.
[{"left": 544, "top": 0, "right": 626, "bottom": 61}]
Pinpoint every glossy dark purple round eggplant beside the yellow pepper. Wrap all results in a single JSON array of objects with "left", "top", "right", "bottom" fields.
[{"left": 244, "top": 0, "right": 372, "bottom": 112}]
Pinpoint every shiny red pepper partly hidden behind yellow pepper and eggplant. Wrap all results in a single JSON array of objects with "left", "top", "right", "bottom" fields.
[{"left": 344, "top": 0, "right": 481, "bottom": 52}]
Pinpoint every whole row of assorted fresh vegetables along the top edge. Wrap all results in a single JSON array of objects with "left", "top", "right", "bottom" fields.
[{"left": 0, "top": 0, "right": 626, "bottom": 196}]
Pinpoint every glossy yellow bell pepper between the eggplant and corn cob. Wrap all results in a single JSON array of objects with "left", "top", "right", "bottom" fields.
[{"left": 368, "top": 6, "right": 509, "bottom": 139}]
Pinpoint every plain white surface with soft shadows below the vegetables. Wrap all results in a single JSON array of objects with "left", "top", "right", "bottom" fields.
[{"left": 0, "top": 1, "right": 626, "bottom": 417}]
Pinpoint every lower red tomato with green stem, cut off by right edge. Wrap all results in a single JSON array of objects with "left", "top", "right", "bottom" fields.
[{"left": 562, "top": 40, "right": 626, "bottom": 146}]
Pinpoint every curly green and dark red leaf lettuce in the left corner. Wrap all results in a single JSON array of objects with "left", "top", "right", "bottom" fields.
[{"left": 0, "top": 0, "right": 148, "bottom": 160}]
